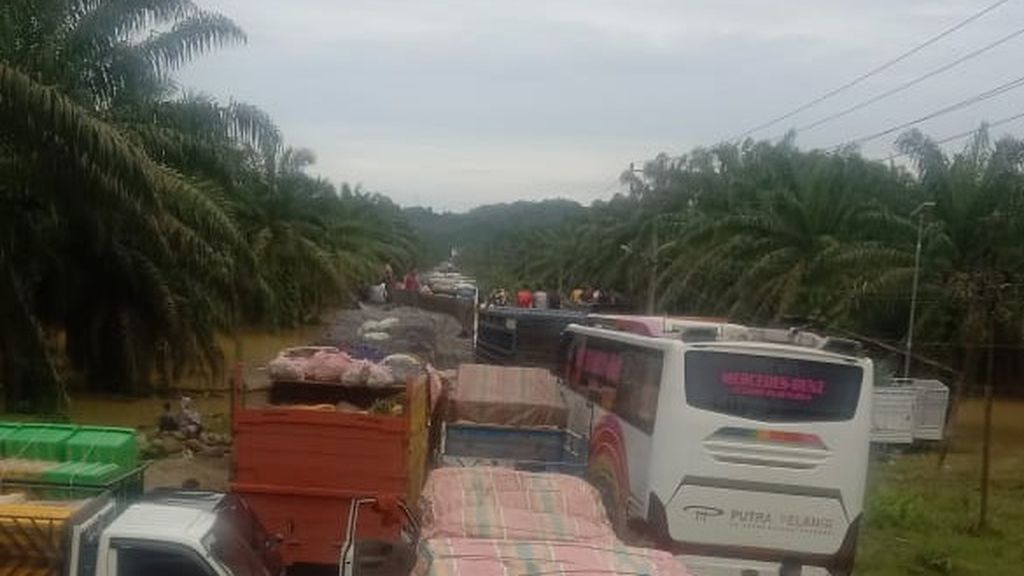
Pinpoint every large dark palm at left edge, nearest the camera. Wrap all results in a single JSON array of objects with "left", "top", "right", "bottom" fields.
[{"left": 0, "top": 0, "right": 246, "bottom": 409}]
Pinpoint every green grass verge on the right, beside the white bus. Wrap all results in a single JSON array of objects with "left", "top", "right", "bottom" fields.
[{"left": 856, "top": 401, "right": 1024, "bottom": 576}]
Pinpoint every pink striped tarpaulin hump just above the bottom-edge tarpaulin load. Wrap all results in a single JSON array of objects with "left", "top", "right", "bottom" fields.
[{"left": 420, "top": 467, "right": 608, "bottom": 528}]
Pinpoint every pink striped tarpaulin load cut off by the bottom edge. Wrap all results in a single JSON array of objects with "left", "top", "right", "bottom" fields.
[{"left": 413, "top": 538, "right": 687, "bottom": 576}]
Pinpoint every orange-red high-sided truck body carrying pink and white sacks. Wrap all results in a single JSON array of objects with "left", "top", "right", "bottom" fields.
[{"left": 230, "top": 360, "right": 432, "bottom": 566}]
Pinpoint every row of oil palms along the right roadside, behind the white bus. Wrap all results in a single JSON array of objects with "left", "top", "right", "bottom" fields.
[{"left": 462, "top": 132, "right": 1024, "bottom": 389}]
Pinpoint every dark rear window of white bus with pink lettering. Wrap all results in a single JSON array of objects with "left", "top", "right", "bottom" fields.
[{"left": 685, "top": 351, "right": 863, "bottom": 422}]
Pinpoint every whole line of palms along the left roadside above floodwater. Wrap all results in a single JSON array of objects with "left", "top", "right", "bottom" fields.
[{"left": 0, "top": 0, "right": 415, "bottom": 411}]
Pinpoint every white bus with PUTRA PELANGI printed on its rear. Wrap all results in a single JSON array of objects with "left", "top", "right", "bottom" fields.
[{"left": 561, "top": 317, "right": 873, "bottom": 576}]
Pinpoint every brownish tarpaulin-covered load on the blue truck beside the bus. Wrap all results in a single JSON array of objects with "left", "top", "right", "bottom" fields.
[{"left": 446, "top": 364, "right": 568, "bottom": 428}]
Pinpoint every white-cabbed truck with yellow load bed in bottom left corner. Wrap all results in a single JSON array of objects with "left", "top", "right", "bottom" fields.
[{"left": 0, "top": 487, "right": 284, "bottom": 576}]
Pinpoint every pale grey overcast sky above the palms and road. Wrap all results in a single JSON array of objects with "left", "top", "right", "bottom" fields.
[{"left": 180, "top": 0, "right": 1024, "bottom": 210}]
